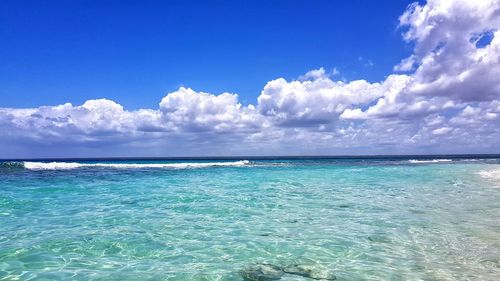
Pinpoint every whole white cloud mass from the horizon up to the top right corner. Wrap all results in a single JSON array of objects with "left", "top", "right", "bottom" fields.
[{"left": 0, "top": 0, "right": 500, "bottom": 157}]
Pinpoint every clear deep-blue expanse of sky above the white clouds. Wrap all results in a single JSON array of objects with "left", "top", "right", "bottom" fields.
[{"left": 0, "top": 1, "right": 411, "bottom": 109}]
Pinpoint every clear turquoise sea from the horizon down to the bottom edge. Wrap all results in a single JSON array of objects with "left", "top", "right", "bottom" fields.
[{"left": 0, "top": 156, "right": 500, "bottom": 280}]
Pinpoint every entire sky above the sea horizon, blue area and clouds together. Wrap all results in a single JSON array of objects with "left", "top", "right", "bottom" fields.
[{"left": 0, "top": 0, "right": 500, "bottom": 158}]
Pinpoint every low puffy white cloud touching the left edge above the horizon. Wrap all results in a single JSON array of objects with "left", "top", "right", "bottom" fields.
[{"left": 0, "top": 99, "right": 148, "bottom": 143}]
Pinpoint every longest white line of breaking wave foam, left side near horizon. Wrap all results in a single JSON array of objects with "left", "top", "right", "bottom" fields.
[{"left": 23, "top": 160, "right": 250, "bottom": 170}]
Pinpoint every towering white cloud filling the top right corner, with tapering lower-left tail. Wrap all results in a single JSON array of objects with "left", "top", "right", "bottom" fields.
[{"left": 344, "top": 1, "right": 500, "bottom": 122}]
